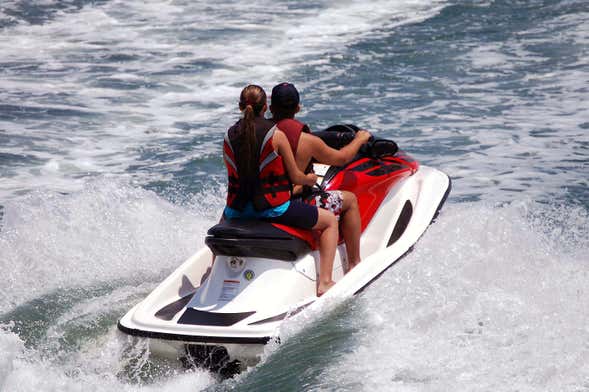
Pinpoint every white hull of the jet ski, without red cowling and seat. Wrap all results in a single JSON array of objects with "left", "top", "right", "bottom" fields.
[{"left": 118, "top": 166, "right": 451, "bottom": 368}]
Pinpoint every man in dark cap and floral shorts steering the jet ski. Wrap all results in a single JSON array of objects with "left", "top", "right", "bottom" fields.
[{"left": 270, "top": 83, "right": 370, "bottom": 269}]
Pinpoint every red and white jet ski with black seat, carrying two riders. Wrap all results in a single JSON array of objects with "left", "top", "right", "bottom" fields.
[{"left": 118, "top": 125, "right": 451, "bottom": 374}]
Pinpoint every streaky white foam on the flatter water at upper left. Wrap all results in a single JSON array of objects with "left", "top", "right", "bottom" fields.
[{"left": 0, "top": 0, "right": 443, "bottom": 198}]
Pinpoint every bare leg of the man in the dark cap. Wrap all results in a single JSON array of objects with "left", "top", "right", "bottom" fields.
[{"left": 341, "top": 191, "right": 362, "bottom": 270}]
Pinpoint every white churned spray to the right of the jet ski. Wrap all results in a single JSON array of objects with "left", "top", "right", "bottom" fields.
[{"left": 321, "top": 202, "right": 589, "bottom": 391}]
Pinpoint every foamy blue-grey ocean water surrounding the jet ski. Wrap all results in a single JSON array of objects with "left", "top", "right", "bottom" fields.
[{"left": 0, "top": 0, "right": 589, "bottom": 392}]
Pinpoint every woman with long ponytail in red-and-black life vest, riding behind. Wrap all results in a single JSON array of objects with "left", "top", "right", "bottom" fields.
[{"left": 223, "top": 85, "right": 338, "bottom": 296}]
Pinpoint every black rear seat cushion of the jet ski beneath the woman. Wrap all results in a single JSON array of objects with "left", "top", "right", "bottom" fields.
[{"left": 205, "top": 219, "right": 310, "bottom": 261}]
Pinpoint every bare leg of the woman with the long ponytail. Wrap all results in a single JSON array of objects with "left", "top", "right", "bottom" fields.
[{"left": 313, "top": 208, "right": 339, "bottom": 297}]
